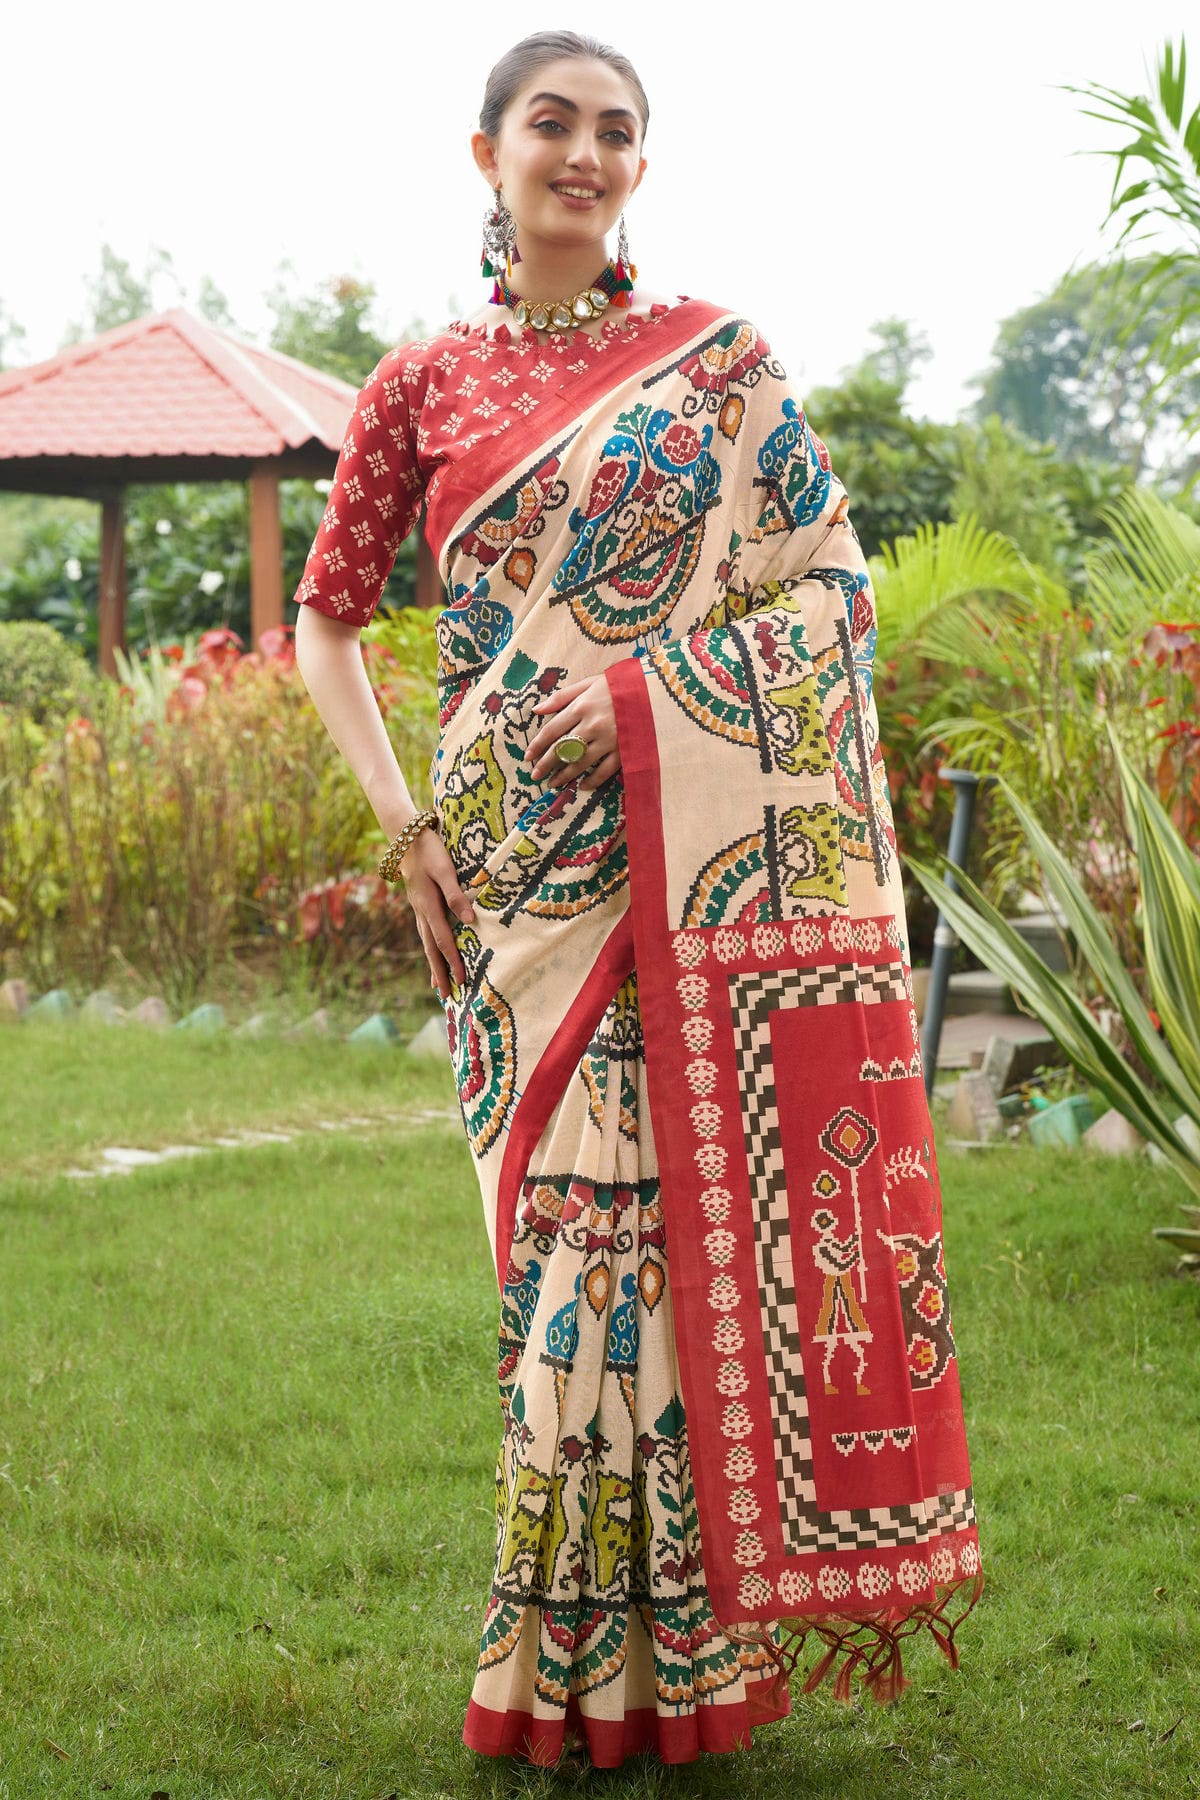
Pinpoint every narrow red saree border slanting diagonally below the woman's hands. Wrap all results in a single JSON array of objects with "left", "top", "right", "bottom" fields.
[{"left": 497, "top": 913, "right": 633, "bottom": 1292}]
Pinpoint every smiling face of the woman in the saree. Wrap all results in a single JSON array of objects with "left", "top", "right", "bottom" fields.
[{"left": 471, "top": 56, "right": 646, "bottom": 255}]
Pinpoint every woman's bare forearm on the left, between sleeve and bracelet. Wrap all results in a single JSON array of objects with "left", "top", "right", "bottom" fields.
[{"left": 295, "top": 607, "right": 416, "bottom": 837}]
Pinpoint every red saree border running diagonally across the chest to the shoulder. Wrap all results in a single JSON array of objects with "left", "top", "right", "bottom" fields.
[{"left": 425, "top": 299, "right": 723, "bottom": 576}]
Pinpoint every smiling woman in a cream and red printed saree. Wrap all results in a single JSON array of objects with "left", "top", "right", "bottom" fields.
[{"left": 297, "top": 32, "right": 979, "bottom": 1766}]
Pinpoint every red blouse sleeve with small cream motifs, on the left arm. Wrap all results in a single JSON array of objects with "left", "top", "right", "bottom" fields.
[{"left": 295, "top": 351, "right": 423, "bottom": 626}]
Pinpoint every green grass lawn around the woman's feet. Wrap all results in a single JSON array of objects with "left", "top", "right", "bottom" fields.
[{"left": 0, "top": 1024, "right": 1200, "bottom": 1800}]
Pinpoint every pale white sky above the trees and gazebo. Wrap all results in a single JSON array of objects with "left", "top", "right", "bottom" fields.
[{"left": 0, "top": 0, "right": 1200, "bottom": 419}]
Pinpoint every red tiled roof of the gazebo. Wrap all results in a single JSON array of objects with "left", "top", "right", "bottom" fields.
[{"left": 0, "top": 308, "right": 354, "bottom": 464}]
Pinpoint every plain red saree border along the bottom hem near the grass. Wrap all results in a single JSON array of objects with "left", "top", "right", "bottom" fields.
[{"left": 462, "top": 1676, "right": 790, "bottom": 1769}]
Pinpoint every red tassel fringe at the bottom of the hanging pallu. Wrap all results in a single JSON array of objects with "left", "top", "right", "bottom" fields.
[{"left": 723, "top": 1571, "right": 984, "bottom": 1706}]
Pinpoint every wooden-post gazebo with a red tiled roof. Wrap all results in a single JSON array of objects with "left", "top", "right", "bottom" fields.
[{"left": 0, "top": 308, "right": 437, "bottom": 675}]
